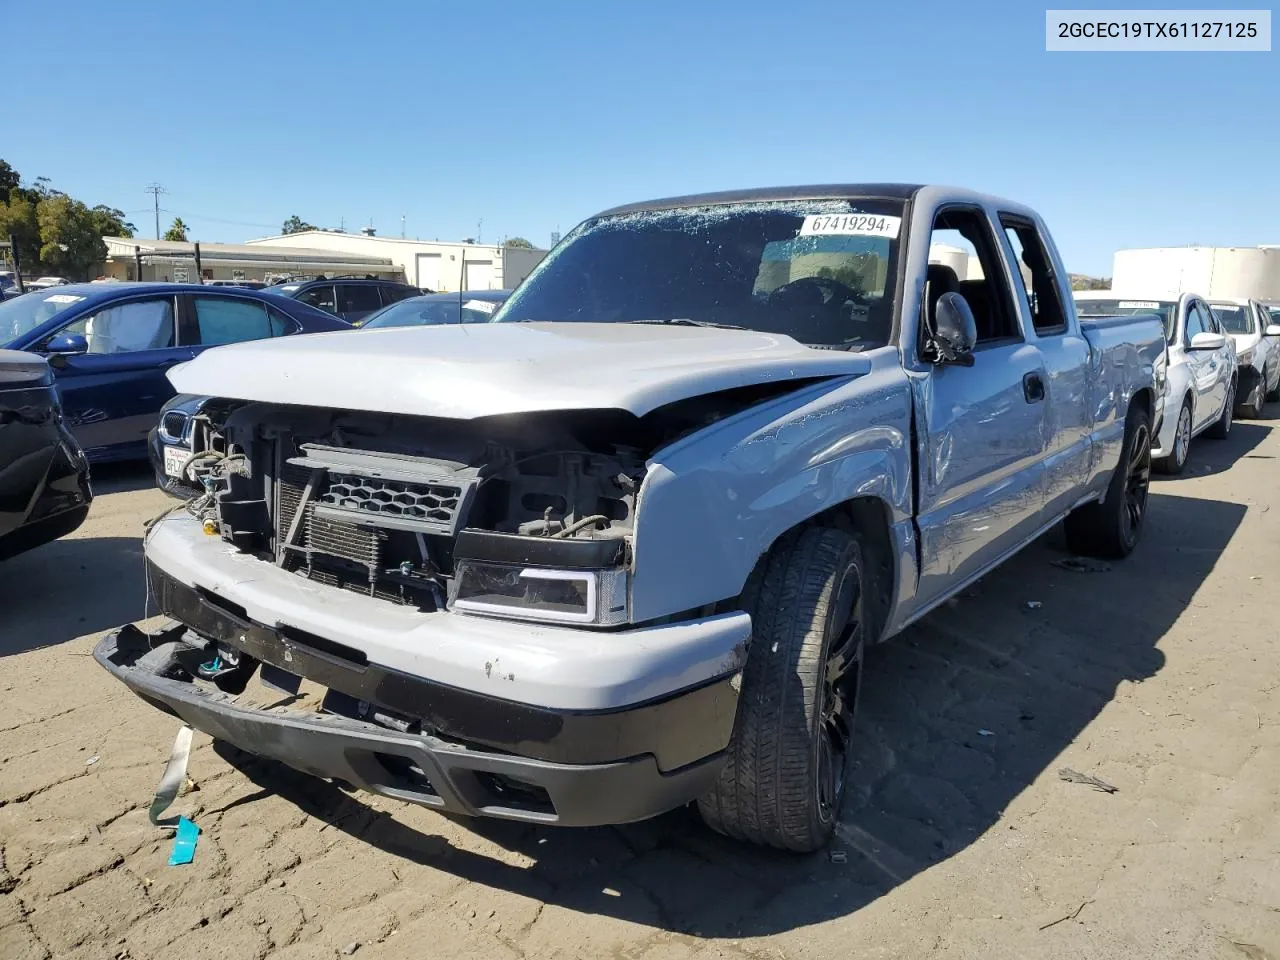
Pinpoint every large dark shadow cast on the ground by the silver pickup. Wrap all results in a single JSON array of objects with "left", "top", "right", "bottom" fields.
[{"left": 218, "top": 491, "right": 1248, "bottom": 937}]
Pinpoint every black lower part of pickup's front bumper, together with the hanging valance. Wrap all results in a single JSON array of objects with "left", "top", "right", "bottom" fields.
[{"left": 95, "top": 560, "right": 737, "bottom": 826}]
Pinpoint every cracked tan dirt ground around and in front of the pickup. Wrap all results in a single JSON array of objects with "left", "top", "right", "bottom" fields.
[{"left": 0, "top": 421, "right": 1280, "bottom": 960}]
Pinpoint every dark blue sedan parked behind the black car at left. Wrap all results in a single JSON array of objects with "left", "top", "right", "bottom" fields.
[{"left": 0, "top": 283, "right": 351, "bottom": 462}]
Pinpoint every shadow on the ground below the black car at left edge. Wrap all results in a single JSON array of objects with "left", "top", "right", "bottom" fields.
[{"left": 0, "top": 536, "right": 146, "bottom": 657}]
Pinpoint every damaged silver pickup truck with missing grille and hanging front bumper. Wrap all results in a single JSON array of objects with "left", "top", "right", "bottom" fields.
[{"left": 96, "top": 184, "right": 1164, "bottom": 850}]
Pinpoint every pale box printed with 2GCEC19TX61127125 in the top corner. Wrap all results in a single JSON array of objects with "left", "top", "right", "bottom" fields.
[{"left": 1044, "top": 10, "right": 1271, "bottom": 54}]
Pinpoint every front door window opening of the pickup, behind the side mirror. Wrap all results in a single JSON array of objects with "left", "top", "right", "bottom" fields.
[{"left": 924, "top": 207, "right": 1023, "bottom": 343}]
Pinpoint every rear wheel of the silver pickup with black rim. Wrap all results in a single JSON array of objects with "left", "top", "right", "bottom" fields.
[{"left": 1064, "top": 406, "right": 1151, "bottom": 559}]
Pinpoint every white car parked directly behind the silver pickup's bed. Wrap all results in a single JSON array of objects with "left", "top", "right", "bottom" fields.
[{"left": 1071, "top": 291, "right": 1238, "bottom": 474}]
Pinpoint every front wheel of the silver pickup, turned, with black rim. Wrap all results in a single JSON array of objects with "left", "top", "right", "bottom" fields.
[{"left": 698, "top": 527, "right": 865, "bottom": 852}]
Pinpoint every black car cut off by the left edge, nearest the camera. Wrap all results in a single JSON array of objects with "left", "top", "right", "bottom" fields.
[{"left": 0, "top": 349, "right": 93, "bottom": 559}]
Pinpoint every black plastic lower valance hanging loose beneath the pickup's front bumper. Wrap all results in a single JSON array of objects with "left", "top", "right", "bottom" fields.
[{"left": 93, "top": 626, "right": 721, "bottom": 827}]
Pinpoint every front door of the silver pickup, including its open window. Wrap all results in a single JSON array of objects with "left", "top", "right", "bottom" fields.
[{"left": 915, "top": 205, "right": 1051, "bottom": 607}]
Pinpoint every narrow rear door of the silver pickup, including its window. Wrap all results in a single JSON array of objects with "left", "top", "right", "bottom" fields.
[{"left": 1000, "top": 214, "right": 1093, "bottom": 516}]
